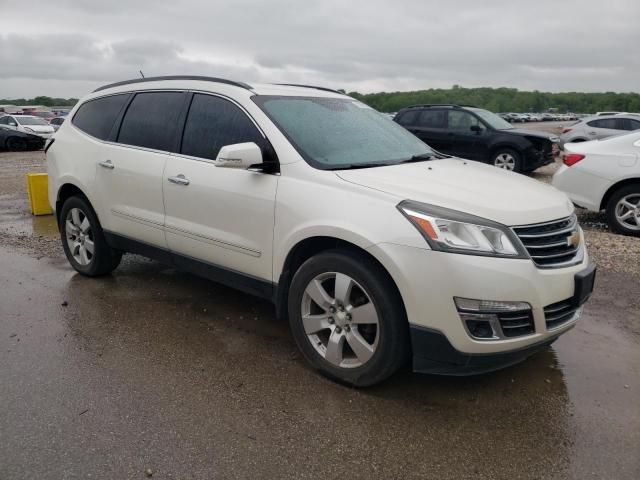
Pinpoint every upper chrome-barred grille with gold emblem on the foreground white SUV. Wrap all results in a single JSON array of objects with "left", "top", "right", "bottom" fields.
[{"left": 513, "top": 215, "right": 581, "bottom": 268}]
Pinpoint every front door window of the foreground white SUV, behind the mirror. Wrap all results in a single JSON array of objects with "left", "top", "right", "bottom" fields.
[{"left": 181, "top": 94, "right": 264, "bottom": 160}]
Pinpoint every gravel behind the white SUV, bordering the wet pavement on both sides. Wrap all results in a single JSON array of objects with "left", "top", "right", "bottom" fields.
[{"left": 0, "top": 146, "right": 640, "bottom": 276}]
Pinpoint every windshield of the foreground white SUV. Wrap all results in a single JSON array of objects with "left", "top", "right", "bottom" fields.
[{"left": 253, "top": 95, "right": 435, "bottom": 170}]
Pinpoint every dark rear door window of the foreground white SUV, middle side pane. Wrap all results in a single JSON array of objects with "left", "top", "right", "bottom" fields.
[{"left": 118, "top": 92, "right": 184, "bottom": 151}]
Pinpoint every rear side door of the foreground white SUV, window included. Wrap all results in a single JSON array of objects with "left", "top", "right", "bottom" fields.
[{"left": 96, "top": 91, "right": 186, "bottom": 248}]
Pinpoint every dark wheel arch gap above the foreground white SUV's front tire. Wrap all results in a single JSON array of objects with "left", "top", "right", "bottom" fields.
[{"left": 274, "top": 235, "right": 404, "bottom": 319}]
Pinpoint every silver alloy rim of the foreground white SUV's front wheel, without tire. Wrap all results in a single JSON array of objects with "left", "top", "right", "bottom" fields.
[{"left": 301, "top": 272, "right": 380, "bottom": 368}]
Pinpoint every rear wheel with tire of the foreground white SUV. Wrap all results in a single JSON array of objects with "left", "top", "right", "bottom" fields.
[{"left": 59, "top": 196, "right": 122, "bottom": 277}]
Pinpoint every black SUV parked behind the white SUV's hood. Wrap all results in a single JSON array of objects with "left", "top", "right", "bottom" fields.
[{"left": 394, "top": 105, "right": 559, "bottom": 172}]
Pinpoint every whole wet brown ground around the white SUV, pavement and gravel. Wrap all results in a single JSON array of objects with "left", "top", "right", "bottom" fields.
[{"left": 0, "top": 143, "right": 640, "bottom": 480}]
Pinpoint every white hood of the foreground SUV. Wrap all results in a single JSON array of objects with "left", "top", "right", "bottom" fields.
[{"left": 336, "top": 158, "right": 573, "bottom": 226}]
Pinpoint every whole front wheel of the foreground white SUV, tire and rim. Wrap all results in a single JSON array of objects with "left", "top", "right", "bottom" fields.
[{"left": 288, "top": 250, "right": 410, "bottom": 387}]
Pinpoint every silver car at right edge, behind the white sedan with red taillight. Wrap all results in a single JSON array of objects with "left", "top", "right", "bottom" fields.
[{"left": 560, "top": 114, "right": 640, "bottom": 145}]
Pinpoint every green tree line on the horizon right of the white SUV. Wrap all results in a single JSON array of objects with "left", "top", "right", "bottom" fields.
[{"left": 349, "top": 85, "right": 640, "bottom": 113}]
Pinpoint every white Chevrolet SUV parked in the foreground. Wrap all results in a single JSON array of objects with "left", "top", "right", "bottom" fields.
[{"left": 47, "top": 77, "right": 595, "bottom": 386}]
